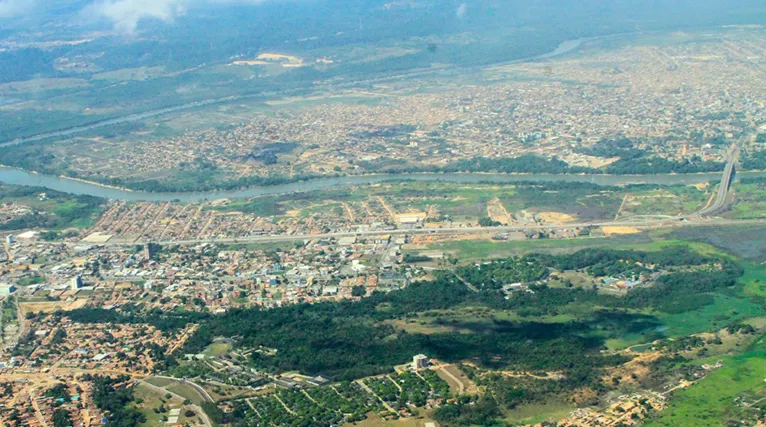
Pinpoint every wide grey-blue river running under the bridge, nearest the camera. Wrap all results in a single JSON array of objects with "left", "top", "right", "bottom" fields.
[{"left": 0, "top": 167, "right": 766, "bottom": 202}]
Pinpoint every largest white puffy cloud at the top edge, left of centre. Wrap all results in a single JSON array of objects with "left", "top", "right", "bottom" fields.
[{"left": 86, "top": 0, "right": 266, "bottom": 33}]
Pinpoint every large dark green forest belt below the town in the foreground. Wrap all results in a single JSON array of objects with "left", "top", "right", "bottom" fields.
[{"left": 68, "top": 248, "right": 741, "bottom": 379}]
